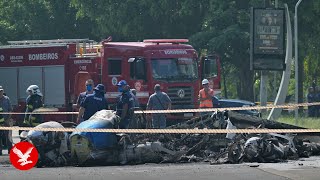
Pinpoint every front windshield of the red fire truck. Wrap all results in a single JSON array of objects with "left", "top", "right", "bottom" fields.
[{"left": 151, "top": 58, "right": 198, "bottom": 81}]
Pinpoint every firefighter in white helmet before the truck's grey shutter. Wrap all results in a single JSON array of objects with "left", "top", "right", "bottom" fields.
[{"left": 23, "top": 85, "right": 43, "bottom": 127}]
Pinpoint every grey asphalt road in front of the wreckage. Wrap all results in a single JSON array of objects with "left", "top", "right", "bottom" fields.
[{"left": 0, "top": 130, "right": 320, "bottom": 180}]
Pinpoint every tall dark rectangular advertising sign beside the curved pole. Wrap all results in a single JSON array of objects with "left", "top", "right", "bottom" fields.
[{"left": 250, "top": 8, "right": 285, "bottom": 70}]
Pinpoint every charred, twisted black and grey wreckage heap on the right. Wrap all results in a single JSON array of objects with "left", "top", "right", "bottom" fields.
[{"left": 129, "top": 111, "right": 320, "bottom": 164}]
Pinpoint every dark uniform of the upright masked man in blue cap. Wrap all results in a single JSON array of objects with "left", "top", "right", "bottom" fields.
[{"left": 117, "top": 91, "right": 134, "bottom": 129}]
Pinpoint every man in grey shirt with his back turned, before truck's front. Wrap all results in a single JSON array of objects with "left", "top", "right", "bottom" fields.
[{"left": 147, "top": 84, "right": 171, "bottom": 129}]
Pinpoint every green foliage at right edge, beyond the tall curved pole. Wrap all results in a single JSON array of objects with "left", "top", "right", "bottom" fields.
[{"left": 284, "top": 0, "right": 320, "bottom": 94}]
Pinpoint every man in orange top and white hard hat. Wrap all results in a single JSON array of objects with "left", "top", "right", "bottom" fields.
[{"left": 199, "top": 79, "right": 214, "bottom": 115}]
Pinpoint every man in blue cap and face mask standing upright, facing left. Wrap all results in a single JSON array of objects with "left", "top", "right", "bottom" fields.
[{"left": 116, "top": 80, "right": 134, "bottom": 129}]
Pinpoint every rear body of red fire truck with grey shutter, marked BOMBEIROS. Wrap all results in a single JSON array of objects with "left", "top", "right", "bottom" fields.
[{"left": 0, "top": 39, "right": 100, "bottom": 121}]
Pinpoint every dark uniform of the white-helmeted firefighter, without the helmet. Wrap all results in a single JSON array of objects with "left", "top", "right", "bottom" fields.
[{"left": 24, "top": 94, "right": 43, "bottom": 127}]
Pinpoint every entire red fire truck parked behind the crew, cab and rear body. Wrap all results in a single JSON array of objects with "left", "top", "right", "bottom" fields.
[{"left": 0, "top": 39, "right": 220, "bottom": 121}]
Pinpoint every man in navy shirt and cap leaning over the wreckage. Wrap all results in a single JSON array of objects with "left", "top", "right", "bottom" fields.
[{"left": 77, "top": 84, "right": 108, "bottom": 124}]
